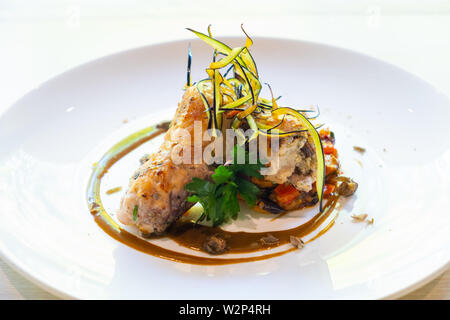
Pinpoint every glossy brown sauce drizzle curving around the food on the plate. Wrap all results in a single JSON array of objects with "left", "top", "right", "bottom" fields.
[{"left": 87, "top": 125, "right": 339, "bottom": 265}]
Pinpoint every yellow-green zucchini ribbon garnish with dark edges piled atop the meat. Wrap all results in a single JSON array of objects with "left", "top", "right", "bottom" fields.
[{"left": 187, "top": 25, "right": 325, "bottom": 211}]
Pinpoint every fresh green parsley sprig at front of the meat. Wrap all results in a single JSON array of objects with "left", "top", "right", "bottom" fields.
[{"left": 186, "top": 146, "right": 263, "bottom": 226}]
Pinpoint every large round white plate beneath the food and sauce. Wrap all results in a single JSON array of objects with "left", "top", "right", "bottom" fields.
[{"left": 0, "top": 38, "right": 450, "bottom": 299}]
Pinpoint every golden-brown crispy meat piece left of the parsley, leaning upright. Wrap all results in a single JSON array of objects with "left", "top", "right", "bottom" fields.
[{"left": 118, "top": 87, "right": 212, "bottom": 235}]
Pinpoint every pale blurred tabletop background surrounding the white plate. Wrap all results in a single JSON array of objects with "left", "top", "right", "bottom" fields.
[{"left": 0, "top": 0, "right": 450, "bottom": 299}]
